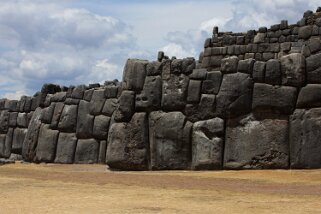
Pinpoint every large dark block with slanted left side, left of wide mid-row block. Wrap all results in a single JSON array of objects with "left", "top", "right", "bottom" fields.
[{"left": 216, "top": 73, "right": 253, "bottom": 117}]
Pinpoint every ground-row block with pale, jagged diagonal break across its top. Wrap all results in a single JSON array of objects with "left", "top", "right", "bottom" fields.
[{"left": 192, "top": 118, "right": 224, "bottom": 170}]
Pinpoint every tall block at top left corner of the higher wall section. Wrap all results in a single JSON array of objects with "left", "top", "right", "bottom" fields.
[{"left": 123, "top": 59, "right": 148, "bottom": 91}]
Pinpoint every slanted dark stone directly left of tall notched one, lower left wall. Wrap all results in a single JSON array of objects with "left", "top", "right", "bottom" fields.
[{"left": 58, "top": 105, "right": 78, "bottom": 132}]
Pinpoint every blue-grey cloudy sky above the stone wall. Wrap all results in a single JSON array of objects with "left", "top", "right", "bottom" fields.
[{"left": 0, "top": 0, "right": 321, "bottom": 99}]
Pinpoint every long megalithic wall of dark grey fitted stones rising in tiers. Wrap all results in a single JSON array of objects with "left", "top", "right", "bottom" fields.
[{"left": 0, "top": 8, "right": 321, "bottom": 170}]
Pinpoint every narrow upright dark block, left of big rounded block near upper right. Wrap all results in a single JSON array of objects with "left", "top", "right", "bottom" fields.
[{"left": 265, "top": 59, "right": 282, "bottom": 85}]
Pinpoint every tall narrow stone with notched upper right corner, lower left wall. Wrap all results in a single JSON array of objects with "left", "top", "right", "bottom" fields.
[{"left": 76, "top": 100, "right": 94, "bottom": 139}]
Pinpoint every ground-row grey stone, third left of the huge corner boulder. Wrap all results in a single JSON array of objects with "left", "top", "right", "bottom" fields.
[{"left": 54, "top": 133, "right": 77, "bottom": 164}]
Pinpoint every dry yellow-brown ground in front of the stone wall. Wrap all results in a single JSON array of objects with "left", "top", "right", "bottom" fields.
[{"left": 0, "top": 163, "right": 321, "bottom": 214}]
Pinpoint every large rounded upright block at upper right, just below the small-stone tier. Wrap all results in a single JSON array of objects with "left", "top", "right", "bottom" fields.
[{"left": 280, "top": 53, "right": 306, "bottom": 87}]
